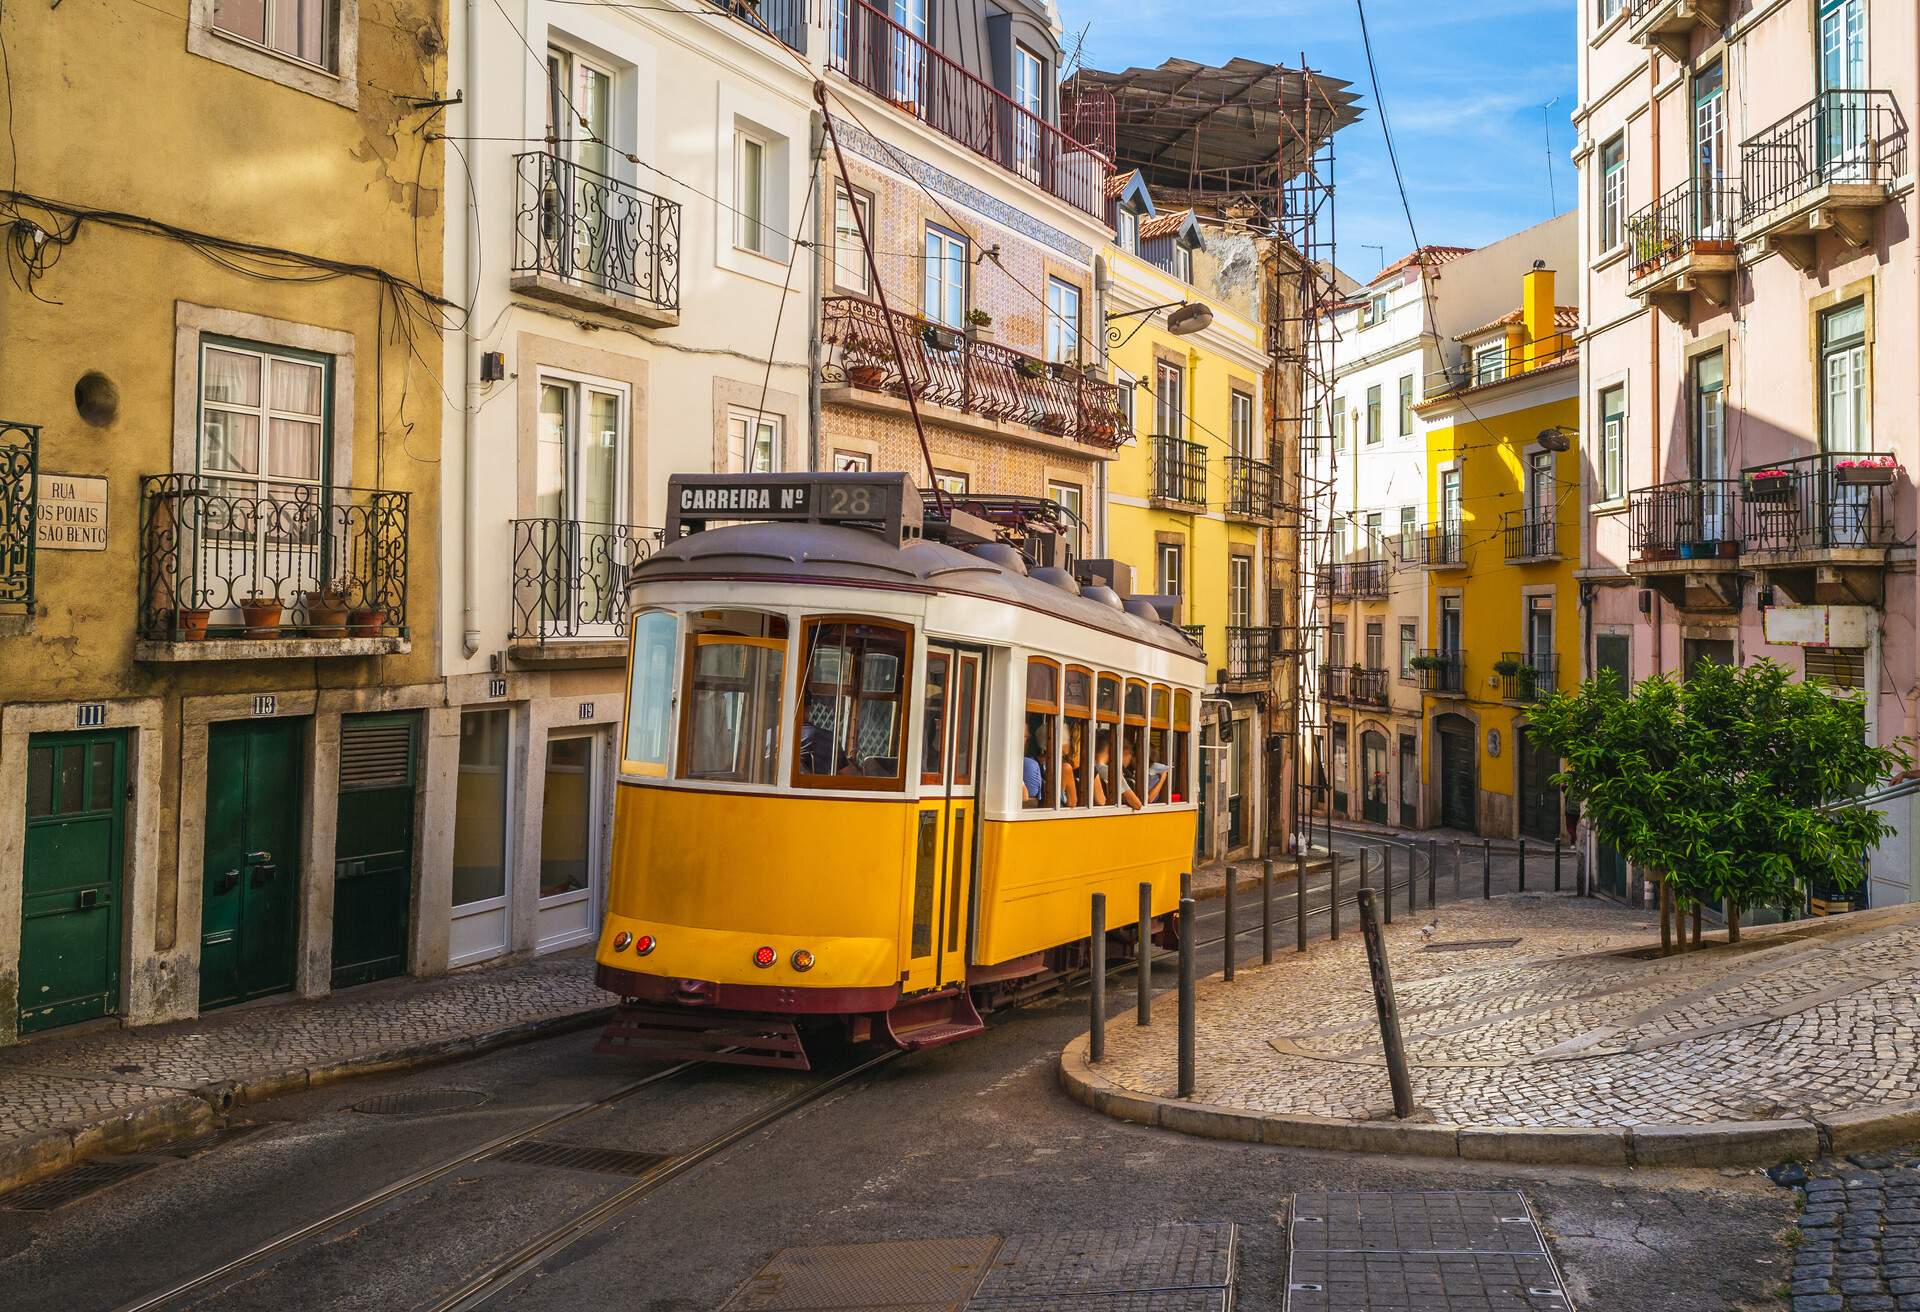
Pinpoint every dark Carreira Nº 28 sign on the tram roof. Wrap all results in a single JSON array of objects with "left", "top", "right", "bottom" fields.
[{"left": 666, "top": 473, "right": 922, "bottom": 542}]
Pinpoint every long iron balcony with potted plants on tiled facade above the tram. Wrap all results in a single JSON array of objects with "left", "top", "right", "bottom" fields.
[{"left": 822, "top": 296, "right": 1133, "bottom": 451}]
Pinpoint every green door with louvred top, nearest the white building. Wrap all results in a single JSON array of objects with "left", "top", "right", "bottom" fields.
[{"left": 332, "top": 715, "right": 419, "bottom": 989}]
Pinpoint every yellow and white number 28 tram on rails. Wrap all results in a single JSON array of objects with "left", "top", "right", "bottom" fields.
[{"left": 597, "top": 474, "right": 1206, "bottom": 1066}]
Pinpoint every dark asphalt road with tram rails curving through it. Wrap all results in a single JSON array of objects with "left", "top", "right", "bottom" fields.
[{"left": 0, "top": 839, "right": 1793, "bottom": 1312}]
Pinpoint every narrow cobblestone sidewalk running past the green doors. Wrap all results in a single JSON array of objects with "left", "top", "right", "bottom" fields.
[{"left": 0, "top": 953, "right": 612, "bottom": 1189}]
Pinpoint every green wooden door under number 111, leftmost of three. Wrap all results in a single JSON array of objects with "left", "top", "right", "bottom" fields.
[{"left": 19, "top": 730, "right": 127, "bottom": 1033}]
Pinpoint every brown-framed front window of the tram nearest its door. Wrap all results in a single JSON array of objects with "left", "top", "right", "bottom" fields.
[{"left": 793, "top": 620, "right": 912, "bottom": 790}]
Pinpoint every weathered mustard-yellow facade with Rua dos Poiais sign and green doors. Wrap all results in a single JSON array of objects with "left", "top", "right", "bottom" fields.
[{"left": 0, "top": 0, "right": 445, "bottom": 1043}]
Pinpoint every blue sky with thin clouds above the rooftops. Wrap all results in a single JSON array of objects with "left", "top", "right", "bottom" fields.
[{"left": 1056, "top": 0, "right": 1576, "bottom": 280}]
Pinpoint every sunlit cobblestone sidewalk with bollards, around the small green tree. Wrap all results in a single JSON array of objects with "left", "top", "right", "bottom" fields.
[{"left": 1075, "top": 895, "right": 1920, "bottom": 1130}]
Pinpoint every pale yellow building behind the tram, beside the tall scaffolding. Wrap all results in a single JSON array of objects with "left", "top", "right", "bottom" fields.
[{"left": 1104, "top": 187, "right": 1277, "bottom": 859}]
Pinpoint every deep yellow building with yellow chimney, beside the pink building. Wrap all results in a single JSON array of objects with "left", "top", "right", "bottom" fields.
[{"left": 1411, "top": 269, "right": 1582, "bottom": 843}]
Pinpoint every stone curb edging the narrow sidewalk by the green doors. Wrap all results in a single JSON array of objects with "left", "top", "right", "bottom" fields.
[{"left": 0, "top": 1005, "right": 614, "bottom": 1193}]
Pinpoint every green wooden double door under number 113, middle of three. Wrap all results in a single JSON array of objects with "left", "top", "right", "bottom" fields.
[{"left": 200, "top": 718, "right": 303, "bottom": 1010}]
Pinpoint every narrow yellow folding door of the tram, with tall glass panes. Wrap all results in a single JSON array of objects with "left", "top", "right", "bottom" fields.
[{"left": 908, "top": 644, "right": 981, "bottom": 989}]
